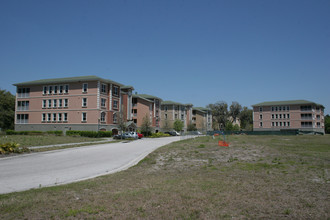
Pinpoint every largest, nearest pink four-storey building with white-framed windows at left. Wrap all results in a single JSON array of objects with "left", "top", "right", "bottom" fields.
[{"left": 14, "top": 76, "right": 134, "bottom": 132}]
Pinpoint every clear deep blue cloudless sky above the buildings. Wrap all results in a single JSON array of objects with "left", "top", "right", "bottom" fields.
[{"left": 0, "top": 0, "right": 330, "bottom": 114}]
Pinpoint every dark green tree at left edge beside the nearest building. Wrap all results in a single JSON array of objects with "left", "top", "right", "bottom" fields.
[{"left": 0, "top": 89, "right": 15, "bottom": 130}]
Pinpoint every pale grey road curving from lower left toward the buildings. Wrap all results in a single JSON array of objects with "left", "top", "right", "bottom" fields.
[{"left": 0, "top": 137, "right": 181, "bottom": 194}]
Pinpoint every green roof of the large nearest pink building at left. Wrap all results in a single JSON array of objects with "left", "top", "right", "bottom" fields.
[{"left": 13, "top": 76, "right": 124, "bottom": 86}]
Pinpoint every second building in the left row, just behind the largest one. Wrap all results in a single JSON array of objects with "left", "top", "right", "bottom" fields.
[{"left": 132, "top": 94, "right": 162, "bottom": 132}]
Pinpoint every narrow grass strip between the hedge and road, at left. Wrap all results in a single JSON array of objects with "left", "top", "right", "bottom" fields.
[{"left": 0, "top": 135, "right": 107, "bottom": 147}]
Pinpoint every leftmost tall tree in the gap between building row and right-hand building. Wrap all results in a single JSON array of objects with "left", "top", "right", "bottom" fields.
[{"left": 207, "top": 101, "right": 228, "bottom": 130}]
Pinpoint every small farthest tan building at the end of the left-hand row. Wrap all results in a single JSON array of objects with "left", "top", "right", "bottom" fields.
[{"left": 191, "top": 107, "right": 212, "bottom": 132}]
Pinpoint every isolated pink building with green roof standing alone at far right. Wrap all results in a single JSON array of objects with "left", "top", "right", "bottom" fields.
[{"left": 252, "top": 100, "right": 324, "bottom": 133}]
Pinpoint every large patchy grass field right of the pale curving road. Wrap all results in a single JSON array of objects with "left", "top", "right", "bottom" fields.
[{"left": 0, "top": 135, "right": 330, "bottom": 219}]
